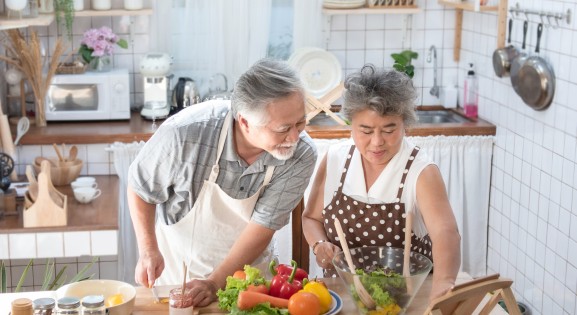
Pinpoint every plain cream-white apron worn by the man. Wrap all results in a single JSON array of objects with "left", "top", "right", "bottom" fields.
[{"left": 155, "top": 113, "right": 274, "bottom": 285}]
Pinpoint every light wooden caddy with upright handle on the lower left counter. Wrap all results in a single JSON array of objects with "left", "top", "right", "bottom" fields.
[{"left": 23, "top": 161, "right": 68, "bottom": 228}]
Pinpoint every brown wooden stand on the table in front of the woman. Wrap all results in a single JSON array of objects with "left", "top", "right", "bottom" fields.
[{"left": 425, "top": 274, "right": 521, "bottom": 315}]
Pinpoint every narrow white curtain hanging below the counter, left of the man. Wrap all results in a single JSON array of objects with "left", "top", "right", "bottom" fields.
[{"left": 106, "top": 141, "right": 144, "bottom": 284}]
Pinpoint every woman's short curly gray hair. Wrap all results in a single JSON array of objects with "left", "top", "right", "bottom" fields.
[{"left": 341, "top": 64, "right": 417, "bottom": 127}]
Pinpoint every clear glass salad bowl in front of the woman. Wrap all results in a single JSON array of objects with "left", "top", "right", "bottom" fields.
[{"left": 333, "top": 246, "right": 433, "bottom": 314}]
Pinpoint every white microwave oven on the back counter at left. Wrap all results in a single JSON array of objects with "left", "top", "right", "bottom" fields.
[{"left": 45, "top": 69, "right": 130, "bottom": 121}]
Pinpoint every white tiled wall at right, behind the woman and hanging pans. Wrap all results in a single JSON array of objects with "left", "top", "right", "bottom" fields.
[{"left": 327, "top": 0, "right": 577, "bottom": 314}]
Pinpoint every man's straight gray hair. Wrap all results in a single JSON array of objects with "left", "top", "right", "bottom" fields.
[{"left": 231, "top": 59, "right": 304, "bottom": 126}]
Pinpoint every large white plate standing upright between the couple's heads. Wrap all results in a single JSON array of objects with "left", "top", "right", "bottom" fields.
[{"left": 289, "top": 49, "right": 342, "bottom": 98}]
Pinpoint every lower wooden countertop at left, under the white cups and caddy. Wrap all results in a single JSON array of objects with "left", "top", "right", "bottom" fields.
[{"left": 0, "top": 175, "right": 118, "bottom": 234}]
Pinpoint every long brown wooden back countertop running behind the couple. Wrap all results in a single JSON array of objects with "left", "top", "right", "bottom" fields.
[{"left": 12, "top": 106, "right": 496, "bottom": 145}]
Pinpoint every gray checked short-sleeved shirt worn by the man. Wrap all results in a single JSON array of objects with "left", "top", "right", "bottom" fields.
[{"left": 128, "top": 101, "right": 317, "bottom": 230}]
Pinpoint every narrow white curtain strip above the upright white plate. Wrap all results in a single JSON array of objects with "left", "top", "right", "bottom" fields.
[{"left": 293, "top": 0, "right": 328, "bottom": 51}]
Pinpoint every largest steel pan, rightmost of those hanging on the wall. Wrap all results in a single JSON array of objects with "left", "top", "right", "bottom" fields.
[{"left": 519, "top": 23, "right": 555, "bottom": 110}]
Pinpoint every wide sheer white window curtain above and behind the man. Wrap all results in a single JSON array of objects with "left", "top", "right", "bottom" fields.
[{"left": 151, "top": 0, "right": 272, "bottom": 94}]
